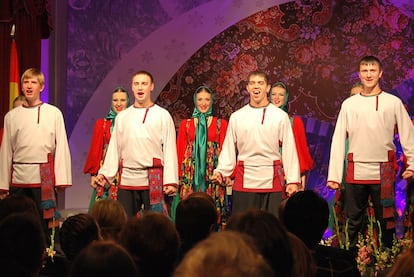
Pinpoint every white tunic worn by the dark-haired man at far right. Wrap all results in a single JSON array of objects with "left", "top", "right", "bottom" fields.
[{"left": 328, "top": 92, "right": 414, "bottom": 184}]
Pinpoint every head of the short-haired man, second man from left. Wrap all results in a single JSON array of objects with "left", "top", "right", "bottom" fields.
[{"left": 132, "top": 74, "right": 154, "bottom": 108}]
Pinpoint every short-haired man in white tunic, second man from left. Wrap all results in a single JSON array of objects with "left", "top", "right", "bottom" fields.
[{"left": 96, "top": 71, "right": 178, "bottom": 216}]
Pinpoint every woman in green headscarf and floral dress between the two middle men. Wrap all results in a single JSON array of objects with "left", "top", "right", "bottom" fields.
[{"left": 171, "top": 86, "right": 228, "bottom": 229}]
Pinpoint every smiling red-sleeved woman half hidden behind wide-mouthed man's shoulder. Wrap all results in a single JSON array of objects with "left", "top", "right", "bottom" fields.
[{"left": 270, "top": 82, "right": 313, "bottom": 190}]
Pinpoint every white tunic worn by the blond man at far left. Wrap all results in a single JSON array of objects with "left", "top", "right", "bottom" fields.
[{"left": 0, "top": 103, "right": 72, "bottom": 190}]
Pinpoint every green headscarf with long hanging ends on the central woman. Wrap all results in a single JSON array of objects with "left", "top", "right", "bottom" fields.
[{"left": 192, "top": 86, "right": 213, "bottom": 191}]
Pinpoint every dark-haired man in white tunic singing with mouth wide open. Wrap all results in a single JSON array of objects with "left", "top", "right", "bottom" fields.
[{"left": 213, "top": 72, "right": 300, "bottom": 216}]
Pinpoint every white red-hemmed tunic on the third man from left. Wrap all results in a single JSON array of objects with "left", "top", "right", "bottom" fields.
[{"left": 215, "top": 104, "right": 300, "bottom": 192}]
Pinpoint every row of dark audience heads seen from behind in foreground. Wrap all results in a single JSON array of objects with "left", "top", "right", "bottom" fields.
[{"left": 0, "top": 190, "right": 414, "bottom": 277}]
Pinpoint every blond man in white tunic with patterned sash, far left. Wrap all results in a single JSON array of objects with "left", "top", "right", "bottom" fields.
[{"left": 0, "top": 68, "right": 72, "bottom": 235}]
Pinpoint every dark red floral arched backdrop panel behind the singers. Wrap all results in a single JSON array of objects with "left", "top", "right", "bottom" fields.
[{"left": 157, "top": 0, "right": 414, "bottom": 201}]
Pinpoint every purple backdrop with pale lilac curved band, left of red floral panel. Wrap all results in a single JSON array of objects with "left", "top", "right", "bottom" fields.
[{"left": 65, "top": 0, "right": 287, "bottom": 208}]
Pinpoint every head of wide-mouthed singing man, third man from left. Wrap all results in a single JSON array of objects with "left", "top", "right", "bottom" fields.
[{"left": 246, "top": 75, "right": 270, "bottom": 107}]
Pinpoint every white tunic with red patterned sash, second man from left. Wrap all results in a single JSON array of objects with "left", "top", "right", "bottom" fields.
[{"left": 98, "top": 104, "right": 178, "bottom": 211}]
